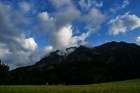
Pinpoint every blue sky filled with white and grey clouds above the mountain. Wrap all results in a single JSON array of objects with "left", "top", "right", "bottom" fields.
[{"left": 0, "top": 0, "right": 140, "bottom": 69}]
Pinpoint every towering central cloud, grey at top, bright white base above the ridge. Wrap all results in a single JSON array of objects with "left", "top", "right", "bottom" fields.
[{"left": 38, "top": 0, "right": 80, "bottom": 50}]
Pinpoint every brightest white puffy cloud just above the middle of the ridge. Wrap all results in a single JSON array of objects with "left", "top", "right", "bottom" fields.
[{"left": 52, "top": 25, "right": 76, "bottom": 49}]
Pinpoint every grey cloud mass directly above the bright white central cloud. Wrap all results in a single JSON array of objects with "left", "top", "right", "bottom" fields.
[{"left": 38, "top": 0, "right": 80, "bottom": 32}]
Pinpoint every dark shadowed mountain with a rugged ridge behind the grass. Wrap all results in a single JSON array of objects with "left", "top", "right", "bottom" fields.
[{"left": 9, "top": 41, "right": 140, "bottom": 84}]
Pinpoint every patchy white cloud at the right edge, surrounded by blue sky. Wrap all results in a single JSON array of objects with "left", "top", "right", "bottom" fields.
[{"left": 109, "top": 13, "right": 140, "bottom": 35}]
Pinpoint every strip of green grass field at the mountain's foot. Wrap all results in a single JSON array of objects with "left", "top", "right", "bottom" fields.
[{"left": 0, "top": 79, "right": 140, "bottom": 93}]
